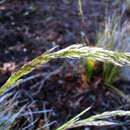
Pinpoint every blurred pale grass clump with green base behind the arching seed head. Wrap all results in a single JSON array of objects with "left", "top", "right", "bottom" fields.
[{"left": 94, "top": 13, "right": 130, "bottom": 102}]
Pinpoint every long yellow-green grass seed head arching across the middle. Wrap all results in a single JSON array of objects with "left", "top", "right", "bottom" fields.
[{"left": 0, "top": 44, "right": 130, "bottom": 95}]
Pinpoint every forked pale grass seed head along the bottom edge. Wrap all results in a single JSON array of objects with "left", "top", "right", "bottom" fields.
[{"left": 56, "top": 108, "right": 130, "bottom": 130}]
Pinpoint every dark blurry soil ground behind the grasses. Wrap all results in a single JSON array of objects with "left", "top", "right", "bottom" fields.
[{"left": 0, "top": 0, "right": 130, "bottom": 130}]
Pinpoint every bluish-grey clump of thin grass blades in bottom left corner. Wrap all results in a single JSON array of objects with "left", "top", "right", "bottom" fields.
[{"left": 0, "top": 91, "right": 54, "bottom": 130}]
